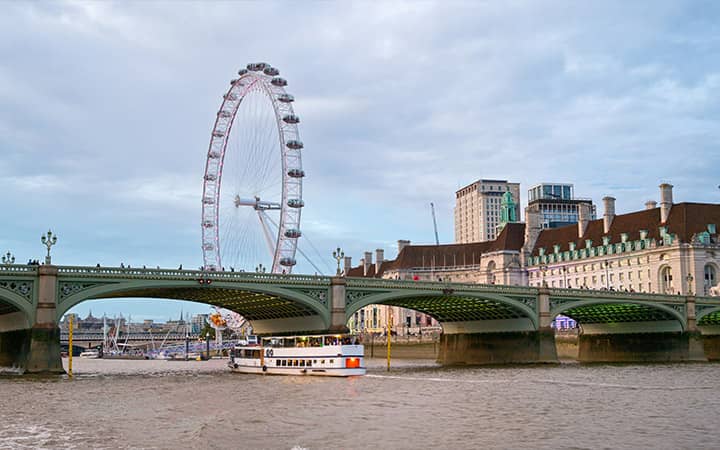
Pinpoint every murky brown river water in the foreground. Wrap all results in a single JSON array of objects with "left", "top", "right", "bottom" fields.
[{"left": 0, "top": 358, "right": 720, "bottom": 450}]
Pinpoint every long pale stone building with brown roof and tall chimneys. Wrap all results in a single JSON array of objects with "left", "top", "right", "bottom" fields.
[{"left": 345, "top": 184, "right": 720, "bottom": 329}]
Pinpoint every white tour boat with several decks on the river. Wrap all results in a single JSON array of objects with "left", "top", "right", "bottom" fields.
[{"left": 228, "top": 334, "right": 365, "bottom": 377}]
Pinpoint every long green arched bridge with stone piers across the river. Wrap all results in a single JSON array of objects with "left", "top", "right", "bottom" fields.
[{"left": 0, "top": 264, "right": 720, "bottom": 372}]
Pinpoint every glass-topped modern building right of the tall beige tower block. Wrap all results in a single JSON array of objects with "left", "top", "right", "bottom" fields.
[{"left": 528, "top": 183, "right": 596, "bottom": 228}]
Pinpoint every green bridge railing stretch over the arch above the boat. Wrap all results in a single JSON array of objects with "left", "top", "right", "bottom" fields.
[{"left": 58, "top": 266, "right": 330, "bottom": 286}]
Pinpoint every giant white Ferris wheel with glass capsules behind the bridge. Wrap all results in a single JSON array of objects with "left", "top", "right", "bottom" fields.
[{"left": 202, "top": 63, "right": 305, "bottom": 273}]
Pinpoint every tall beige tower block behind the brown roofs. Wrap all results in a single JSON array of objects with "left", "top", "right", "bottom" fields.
[{"left": 455, "top": 180, "right": 520, "bottom": 244}]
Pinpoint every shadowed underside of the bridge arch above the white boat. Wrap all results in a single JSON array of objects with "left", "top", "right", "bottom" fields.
[{"left": 86, "top": 287, "right": 326, "bottom": 334}]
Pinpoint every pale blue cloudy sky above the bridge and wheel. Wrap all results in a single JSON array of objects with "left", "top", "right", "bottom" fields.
[{"left": 0, "top": 0, "right": 720, "bottom": 321}]
